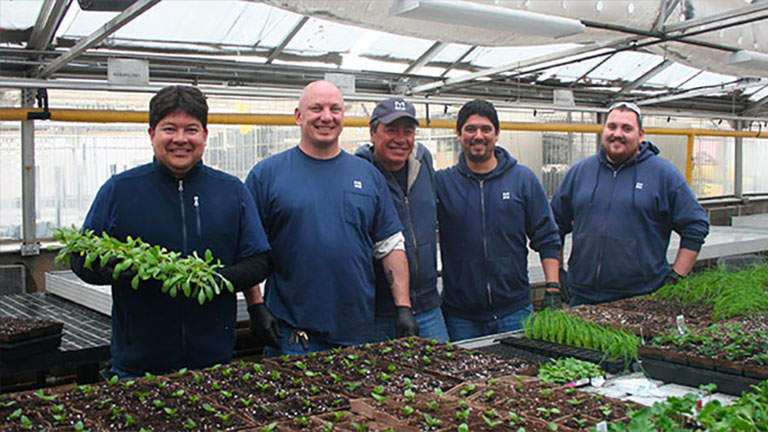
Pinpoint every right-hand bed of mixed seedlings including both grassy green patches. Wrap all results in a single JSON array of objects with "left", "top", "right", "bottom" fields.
[{"left": 526, "top": 266, "right": 768, "bottom": 378}]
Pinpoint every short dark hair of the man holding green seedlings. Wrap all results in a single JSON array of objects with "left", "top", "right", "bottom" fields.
[{"left": 149, "top": 86, "right": 208, "bottom": 129}]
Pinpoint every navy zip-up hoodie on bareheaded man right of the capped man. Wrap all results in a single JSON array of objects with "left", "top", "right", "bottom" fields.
[{"left": 435, "top": 147, "right": 560, "bottom": 321}]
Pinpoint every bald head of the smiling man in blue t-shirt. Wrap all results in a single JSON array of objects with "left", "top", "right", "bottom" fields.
[{"left": 294, "top": 80, "right": 344, "bottom": 158}]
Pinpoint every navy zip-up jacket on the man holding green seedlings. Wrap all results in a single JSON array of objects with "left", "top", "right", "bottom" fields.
[{"left": 73, "top": 161, "right": 269, "bottom": 375}]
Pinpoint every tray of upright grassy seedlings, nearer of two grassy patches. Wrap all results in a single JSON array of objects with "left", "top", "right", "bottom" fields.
[{"left": 499, "top": 309, "right": 640, "bottom": 373}]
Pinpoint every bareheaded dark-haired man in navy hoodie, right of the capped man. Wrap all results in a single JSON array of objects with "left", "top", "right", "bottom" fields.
[{"left": 435, "top": 99, "right": 560, "bottom": 341}]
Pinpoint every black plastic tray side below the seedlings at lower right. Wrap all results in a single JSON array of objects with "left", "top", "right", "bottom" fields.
[{"left": 640, "top": 354, "right": 763, "bottom": 396}]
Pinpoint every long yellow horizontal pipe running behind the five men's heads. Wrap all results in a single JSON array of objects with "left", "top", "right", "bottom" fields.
[{"left": 0, "top": 108, "right": 768, "bottom": 138}]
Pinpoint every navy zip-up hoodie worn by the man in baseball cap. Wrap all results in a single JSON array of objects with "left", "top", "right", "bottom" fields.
[{"left": 355, "top": 143, "right": 440, "bottom": 317}]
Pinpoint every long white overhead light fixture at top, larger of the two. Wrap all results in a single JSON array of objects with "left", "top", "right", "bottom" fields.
[{"left": 390, "top": 0, "right": 587, "bottom": 38}]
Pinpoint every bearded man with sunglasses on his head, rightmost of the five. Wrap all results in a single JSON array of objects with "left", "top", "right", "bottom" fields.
[{"left": 552, "top": 102, "right": 709, "bottom": 306}]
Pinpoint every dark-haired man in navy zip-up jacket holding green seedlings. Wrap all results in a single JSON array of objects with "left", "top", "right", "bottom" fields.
[{"left": 71, "top": 86, "right": 270, "bottom": 379}]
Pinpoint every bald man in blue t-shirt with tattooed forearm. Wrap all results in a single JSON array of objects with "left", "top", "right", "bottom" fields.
[{"left": 246, "top": 81, "right": 418, "bottom": 357}]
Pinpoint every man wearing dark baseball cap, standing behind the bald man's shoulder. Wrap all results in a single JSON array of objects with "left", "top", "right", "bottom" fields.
[{"left": 355, "top": 97, "right": 448, "bottom": 342}]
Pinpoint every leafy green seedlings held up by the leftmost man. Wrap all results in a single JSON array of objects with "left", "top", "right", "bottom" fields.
[{"left": 53, "top": 227, "right": 234, "bottom": 305}]
